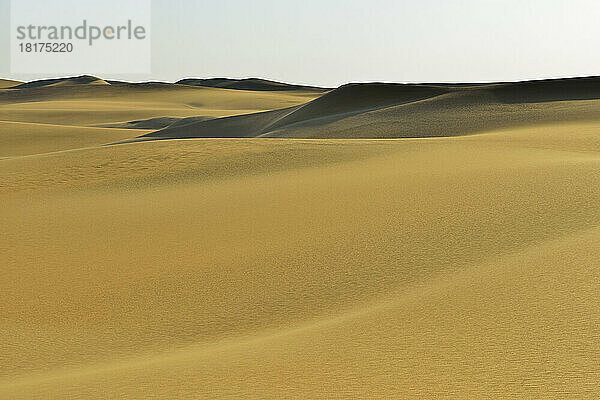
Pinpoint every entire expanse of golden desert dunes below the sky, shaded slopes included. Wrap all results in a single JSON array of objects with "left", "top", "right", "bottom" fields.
[{"left": 0, "top": 77, "right": 600, "bottom": 399}]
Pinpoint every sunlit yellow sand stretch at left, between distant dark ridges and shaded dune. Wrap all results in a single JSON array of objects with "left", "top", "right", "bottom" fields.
[{"left": 0, "top": 83, "right": 318, "bottom": 129}]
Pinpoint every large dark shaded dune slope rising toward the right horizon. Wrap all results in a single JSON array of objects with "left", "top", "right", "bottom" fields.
[{"left": 146, "top": 77, "right": 600, "bottom": 139}]
